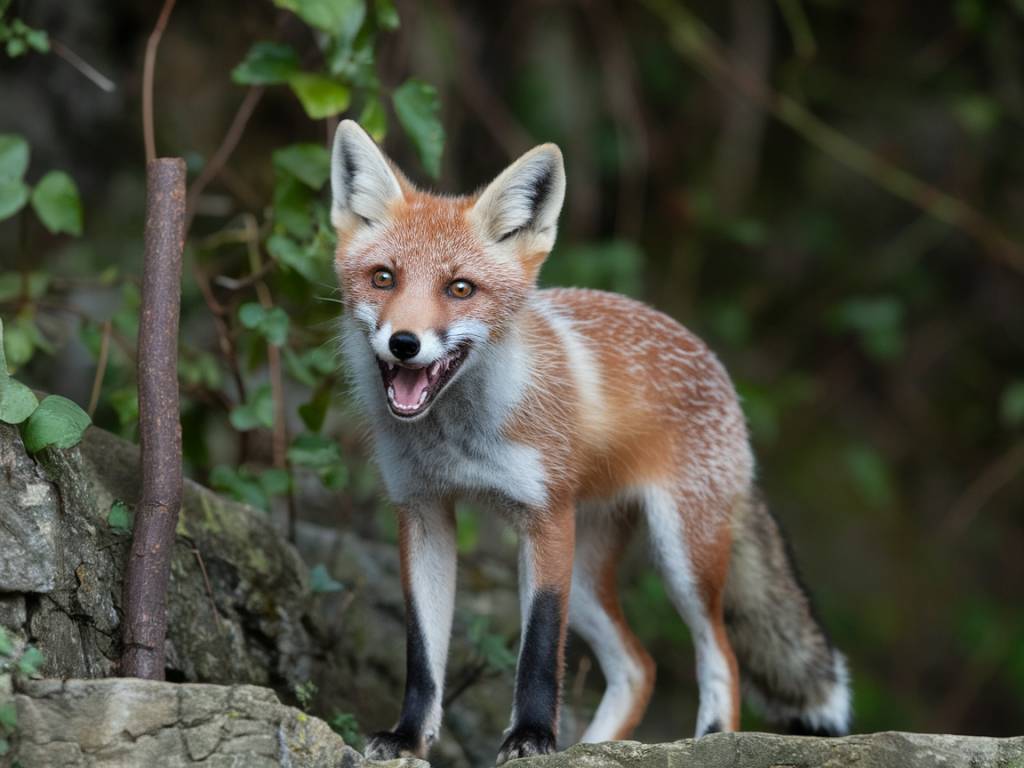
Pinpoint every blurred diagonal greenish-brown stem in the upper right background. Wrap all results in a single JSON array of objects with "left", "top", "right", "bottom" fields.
[{"left": 644, "top": 0, "right": 1024, "bottom": 274}]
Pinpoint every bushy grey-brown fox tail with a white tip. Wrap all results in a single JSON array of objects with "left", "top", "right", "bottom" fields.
[{"left": 725, "top": 498, "right": 851, "bottom": 735}]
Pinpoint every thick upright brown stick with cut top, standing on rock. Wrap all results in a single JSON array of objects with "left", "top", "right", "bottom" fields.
[{"left": 121, "top": 158, "right": 185, "bottom": 680}]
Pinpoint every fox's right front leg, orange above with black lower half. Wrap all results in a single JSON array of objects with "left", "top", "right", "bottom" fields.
[{"left": 497, "top": 504, "right": 575, "bottom": 765}]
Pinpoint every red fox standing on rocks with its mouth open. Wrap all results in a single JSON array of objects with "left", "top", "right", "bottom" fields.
[{"left": 331, "top": 121, "right": 851, "bottom": 765}]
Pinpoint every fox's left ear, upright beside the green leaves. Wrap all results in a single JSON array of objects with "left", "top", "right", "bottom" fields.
[{"left": 331, "top": 120, "right": 402, "bottom": 229}]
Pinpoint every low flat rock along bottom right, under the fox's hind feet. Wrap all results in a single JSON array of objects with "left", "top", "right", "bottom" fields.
[{"left": 509, "top": 732, "right": 1024, "bottom": 768}]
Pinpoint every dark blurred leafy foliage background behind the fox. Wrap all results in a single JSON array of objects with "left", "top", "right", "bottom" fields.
[{"left": 0, "top": 0, "right": 1024, "bottom": 753}]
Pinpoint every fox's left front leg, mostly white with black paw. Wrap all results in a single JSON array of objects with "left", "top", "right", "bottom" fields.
[{"left": 367, "top": 503, "right": 456, "bottom": 760}]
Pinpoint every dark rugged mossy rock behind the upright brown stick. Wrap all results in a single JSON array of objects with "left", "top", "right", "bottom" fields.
[{"left": 0, "top": 424, "right": 322, "bottom": 690}]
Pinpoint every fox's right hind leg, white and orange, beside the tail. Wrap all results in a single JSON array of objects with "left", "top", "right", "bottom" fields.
[{"left": 643, "top": 487, "right": 739, "bottom": 736}]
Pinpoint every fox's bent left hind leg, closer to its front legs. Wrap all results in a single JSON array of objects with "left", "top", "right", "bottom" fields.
[{"left": 569, "top": 509, "right": 654, "bottom": 742}]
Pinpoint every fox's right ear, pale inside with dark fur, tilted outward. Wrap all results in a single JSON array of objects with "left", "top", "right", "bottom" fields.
[{"left": 472, "top": 144, "right": 565, "bottom": 251}]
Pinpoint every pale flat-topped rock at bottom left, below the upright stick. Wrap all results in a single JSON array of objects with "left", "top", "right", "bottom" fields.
[{"left": 10, "top": 678, "right": 427, "bottom": 768}]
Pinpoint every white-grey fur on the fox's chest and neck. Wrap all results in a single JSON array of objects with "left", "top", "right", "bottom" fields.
[{"left": 342, "top": 322, "right": 547, "bottom": 507}]
